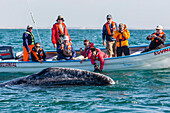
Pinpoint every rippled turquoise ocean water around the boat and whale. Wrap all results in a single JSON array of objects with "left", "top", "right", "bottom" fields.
[{"left": 0, "top": 29, "right": 170, "bottom": 113}]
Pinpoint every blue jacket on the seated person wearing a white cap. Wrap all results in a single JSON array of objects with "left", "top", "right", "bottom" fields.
[{"left": 57, "top": 45, "right": 76, "bottom": 60}]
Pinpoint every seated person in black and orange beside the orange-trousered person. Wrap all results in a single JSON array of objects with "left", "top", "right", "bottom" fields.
[{"left": 31, "top": 43, "right": 46, "bottom": 63}]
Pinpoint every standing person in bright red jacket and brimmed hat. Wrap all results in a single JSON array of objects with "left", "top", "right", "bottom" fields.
[{"left": 51, "top": 15, "right": 71, "bottom": 52}]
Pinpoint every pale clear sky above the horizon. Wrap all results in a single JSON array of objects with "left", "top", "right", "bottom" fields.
[{"left": 0, "top": 0, "right": 170, "bottom": 29}]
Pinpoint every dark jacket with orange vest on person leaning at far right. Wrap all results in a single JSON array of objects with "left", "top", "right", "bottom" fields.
[{"left": 146, "top": 33, "right": 166, "bottom": 50}]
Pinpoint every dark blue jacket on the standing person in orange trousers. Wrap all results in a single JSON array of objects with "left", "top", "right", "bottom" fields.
[{"left": 22, "top": 30, "right": 35, "bottom": 51}]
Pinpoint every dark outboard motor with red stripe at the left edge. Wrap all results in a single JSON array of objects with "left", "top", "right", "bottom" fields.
[{"left": 0, "top": 46, "right": 14, "bottom": 60}]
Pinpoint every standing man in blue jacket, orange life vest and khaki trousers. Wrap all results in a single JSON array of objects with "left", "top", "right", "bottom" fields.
[{"left": 102, "top": 14, "right": 117, "bottom": 57}]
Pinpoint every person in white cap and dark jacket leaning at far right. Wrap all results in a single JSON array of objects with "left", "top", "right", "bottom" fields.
[{"left": 142, "top": 25, "right": 166, "bottom": 53}]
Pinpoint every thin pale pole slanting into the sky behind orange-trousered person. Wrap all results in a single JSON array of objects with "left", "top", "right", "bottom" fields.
[{"left": 26, "top": 0, "right": 43, "bottom": 48}]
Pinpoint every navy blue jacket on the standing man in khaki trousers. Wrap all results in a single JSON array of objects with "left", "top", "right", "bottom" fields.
[{"left": 102, "top": 23, "right": 117, "bottom": 41}]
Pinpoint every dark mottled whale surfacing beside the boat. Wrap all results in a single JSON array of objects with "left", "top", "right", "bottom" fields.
[{"left": 0, "top": 67, "right": 115, "bottom": 87}]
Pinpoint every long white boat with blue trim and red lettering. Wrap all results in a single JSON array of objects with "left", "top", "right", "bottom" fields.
[{"left": 0, "top": 44, "right": 170, "bottom": 73}]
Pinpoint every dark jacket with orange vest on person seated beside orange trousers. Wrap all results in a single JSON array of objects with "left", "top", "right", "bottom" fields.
[{"left": 31, "top": 47, "right": 46, "bottom": 62}]
